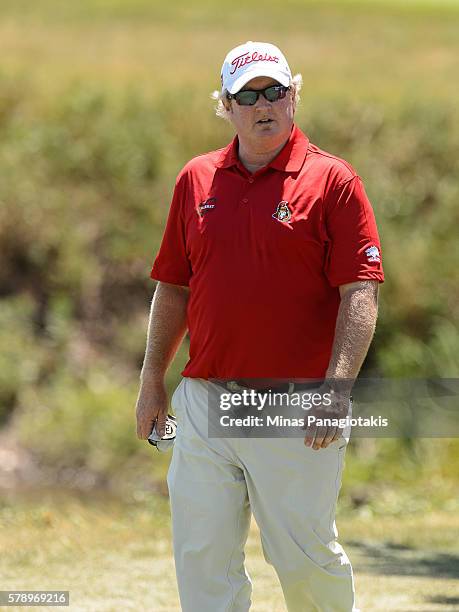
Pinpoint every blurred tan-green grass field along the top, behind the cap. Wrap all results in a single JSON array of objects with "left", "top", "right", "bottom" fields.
[{"left": 0, "top": 0, "right": 459, "bottom": 109}]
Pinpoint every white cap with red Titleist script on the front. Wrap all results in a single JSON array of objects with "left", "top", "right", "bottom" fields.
[{"left": 221, "top": 40, "right": 292, "bottom": 94}]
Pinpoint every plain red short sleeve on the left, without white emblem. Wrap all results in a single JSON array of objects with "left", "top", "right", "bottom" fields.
[{"left": 150, "top": 177, "right": 191, "bottom": 287}]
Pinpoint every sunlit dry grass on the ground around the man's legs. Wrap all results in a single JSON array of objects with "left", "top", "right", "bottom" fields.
[{"left": 0, "top": 490, "right": 459, "bottom": 612}]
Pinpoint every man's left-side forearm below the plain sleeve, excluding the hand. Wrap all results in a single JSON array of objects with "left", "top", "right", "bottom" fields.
[{"left": 140, "top": 283, "right": 189, "bottom": 383}]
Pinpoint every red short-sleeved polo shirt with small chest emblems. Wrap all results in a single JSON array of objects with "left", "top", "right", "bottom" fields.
[{"left": 151, "top": 126, "right": 384, "bottom": 379}]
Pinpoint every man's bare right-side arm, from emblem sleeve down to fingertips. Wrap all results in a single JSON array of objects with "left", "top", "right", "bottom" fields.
[{"left": 304, "top": 281, "right": 379, "bottom": 450}]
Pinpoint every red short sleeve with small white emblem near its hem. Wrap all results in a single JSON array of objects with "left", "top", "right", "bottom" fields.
[{"left": 325, "top": 176, "right": 384, "bottom": 287}]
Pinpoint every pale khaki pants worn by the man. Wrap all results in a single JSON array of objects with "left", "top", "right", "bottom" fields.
[{"left": 167, "top": 378, "right": 356, "bottom": 612}]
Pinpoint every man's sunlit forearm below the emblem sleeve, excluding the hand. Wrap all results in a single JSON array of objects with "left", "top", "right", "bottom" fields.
[{"left": 326, "top": 281, "right": 378, "bottom": 382}]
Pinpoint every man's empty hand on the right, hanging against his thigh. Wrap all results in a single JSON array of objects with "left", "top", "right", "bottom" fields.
[{"left": 304, "top": 384, "right": 350, "bottom": 450}]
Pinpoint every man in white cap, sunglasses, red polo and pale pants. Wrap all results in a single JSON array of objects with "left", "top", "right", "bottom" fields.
[{"left": 137, "top": 42, "right": 383, "bottom": 612}]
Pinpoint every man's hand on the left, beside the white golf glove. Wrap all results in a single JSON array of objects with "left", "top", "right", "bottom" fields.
[{"left": 136, "top": 381, "right": 169, "bottom": 440}]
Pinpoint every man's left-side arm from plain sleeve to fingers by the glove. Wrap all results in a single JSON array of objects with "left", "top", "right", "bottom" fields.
[{"left": 136, "top": 282, "right": 189, "bottom": 439}]
